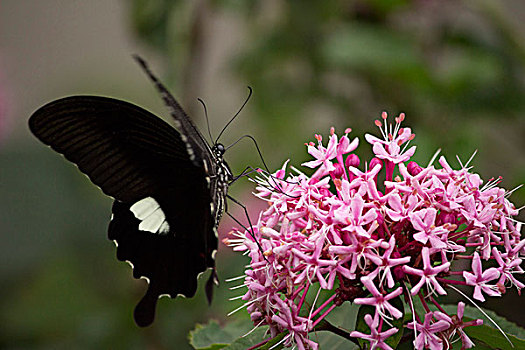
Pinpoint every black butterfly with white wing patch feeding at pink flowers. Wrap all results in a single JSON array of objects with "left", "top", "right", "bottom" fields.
[{"left": 29, "top": 57, "right": 233, "bottom": 326}]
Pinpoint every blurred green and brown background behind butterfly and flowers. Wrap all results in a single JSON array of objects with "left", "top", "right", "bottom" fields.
[{"left": 0, "top": 0, "right": 525, "bottom": 349}]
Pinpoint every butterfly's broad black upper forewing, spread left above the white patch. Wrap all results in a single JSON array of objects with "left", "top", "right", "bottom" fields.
[{"left": 29, "top": 96, "right": 191, "bottom": 202}]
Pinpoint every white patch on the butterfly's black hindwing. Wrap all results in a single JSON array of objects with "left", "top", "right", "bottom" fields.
[{"left": 129, "top": 197, "right": 170, "bottom": 234}]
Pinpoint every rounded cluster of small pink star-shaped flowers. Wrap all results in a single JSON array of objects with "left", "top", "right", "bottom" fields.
[{"left": 226, "top": 113, "right": 525, "bottom": 350}]
